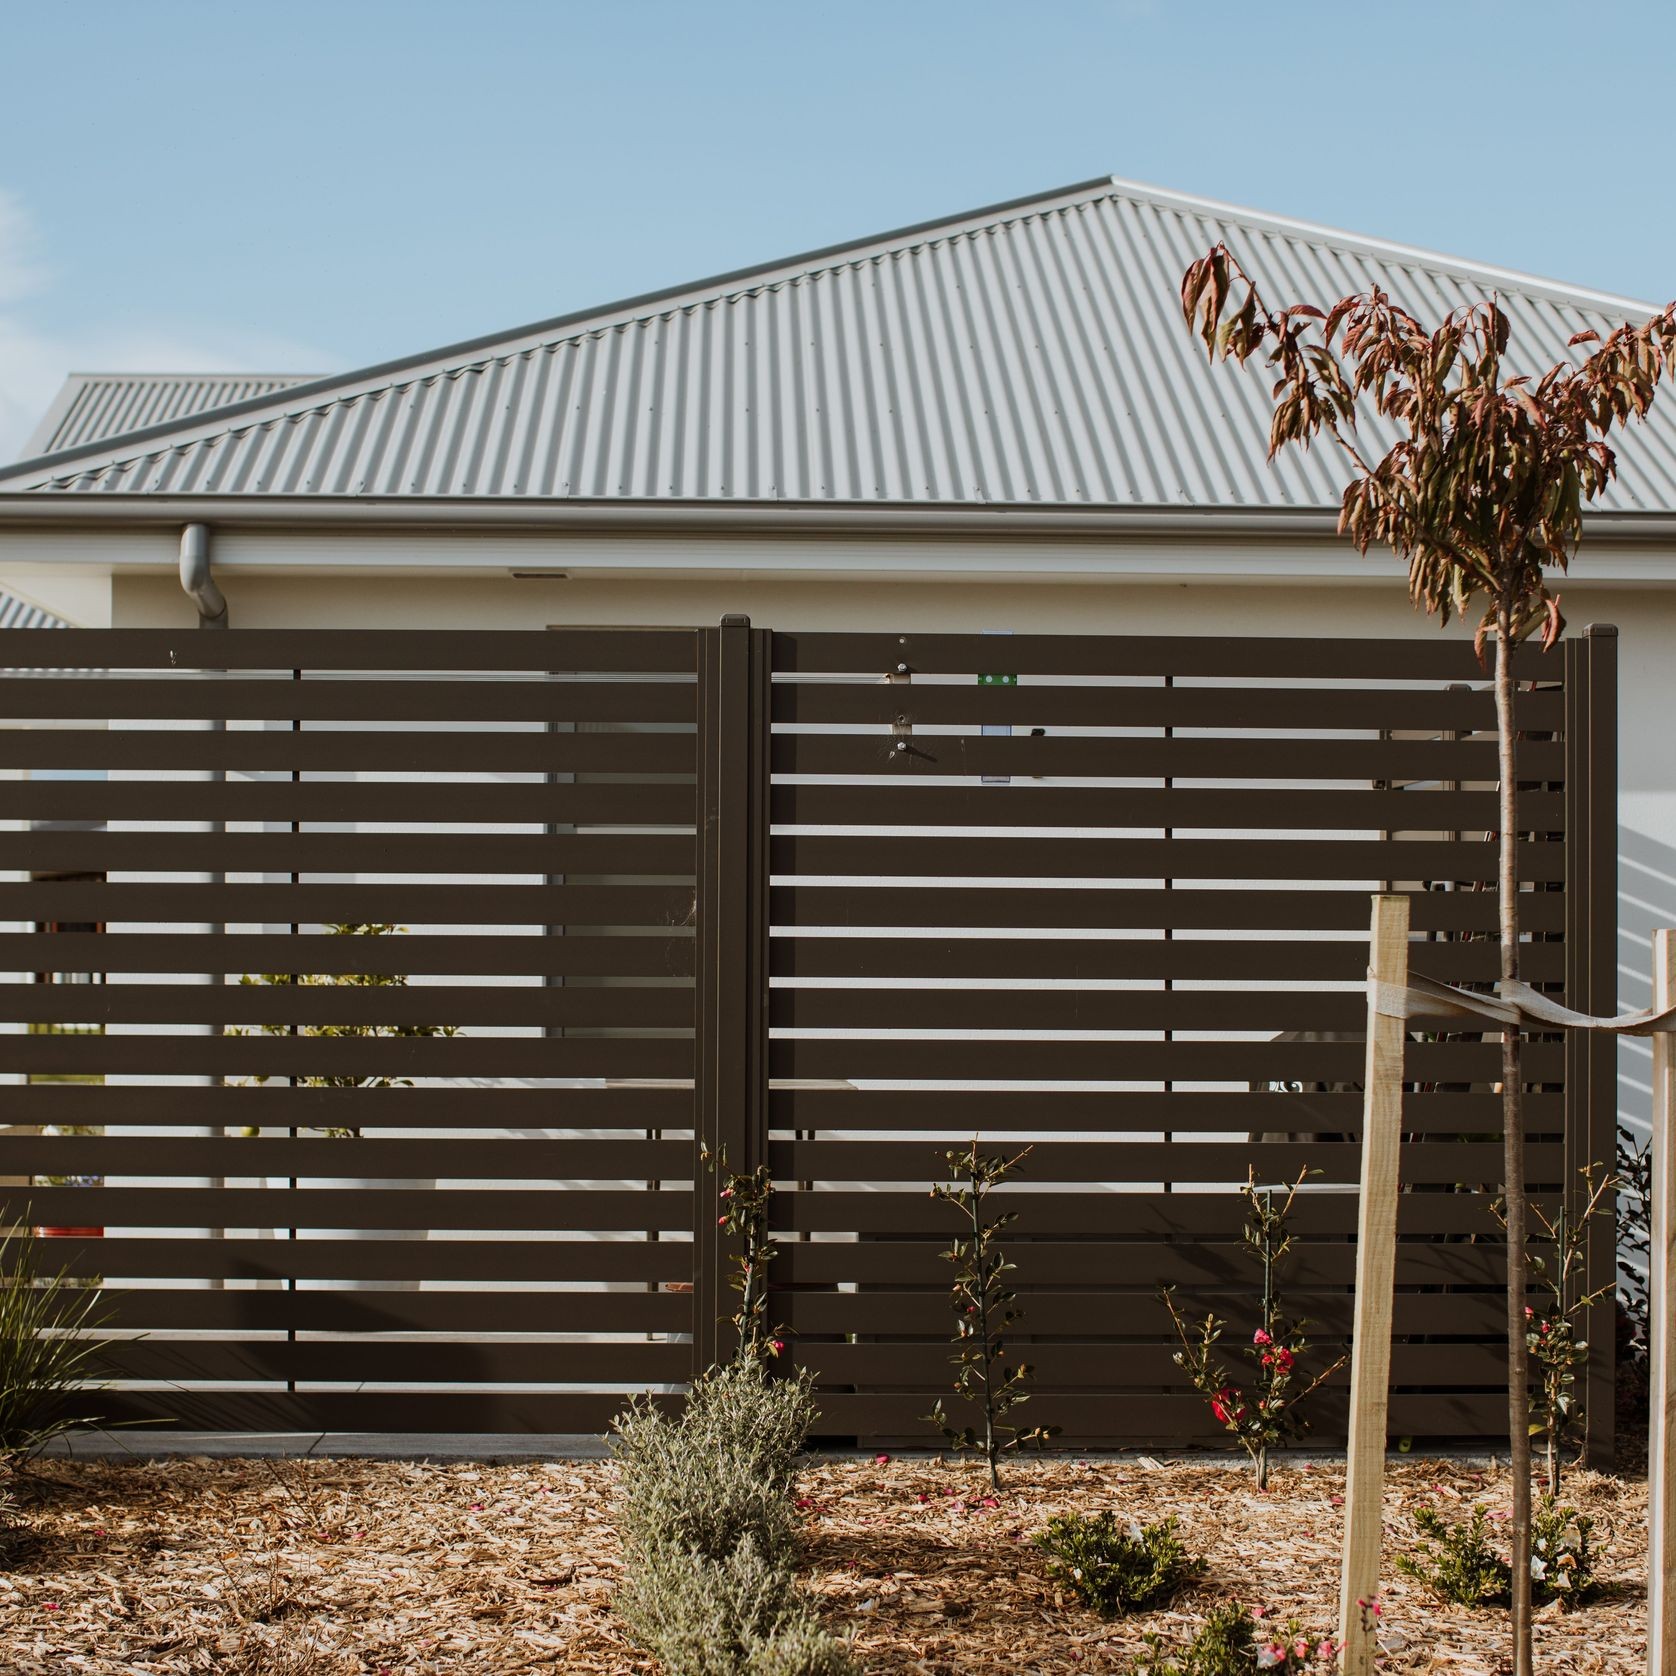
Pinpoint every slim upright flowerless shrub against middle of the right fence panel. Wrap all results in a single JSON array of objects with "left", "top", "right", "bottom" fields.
[{"left": 923, "top": 1140, "right": 1059, "bottom": 1490}]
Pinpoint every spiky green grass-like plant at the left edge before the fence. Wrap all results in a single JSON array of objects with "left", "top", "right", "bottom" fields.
[{"left": 0, "top": 1229, "right": 107, "bottom": 1467}]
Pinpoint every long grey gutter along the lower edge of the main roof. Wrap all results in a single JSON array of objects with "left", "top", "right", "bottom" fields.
[{"left": 0, "top": 493, "right": 1676, "bottom": 543}]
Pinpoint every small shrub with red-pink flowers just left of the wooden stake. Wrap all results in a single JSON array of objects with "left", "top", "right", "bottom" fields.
[{"left": 1161, "top": 1175, "right": 1349, "bottom": 1490}]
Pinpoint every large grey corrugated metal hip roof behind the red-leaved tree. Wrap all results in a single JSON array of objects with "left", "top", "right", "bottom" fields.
[{"left": 0, "top": 179, "right": 1676, "bottom": 511}]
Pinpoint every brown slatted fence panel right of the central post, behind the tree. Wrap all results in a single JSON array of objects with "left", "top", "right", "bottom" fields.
[{"left": 769, "top": 634, "right": 1612, "bottom": 1451}]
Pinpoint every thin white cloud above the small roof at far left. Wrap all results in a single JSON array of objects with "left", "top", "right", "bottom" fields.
[{"left": 0, "top": 188, "right": 334, "bottom": 461}]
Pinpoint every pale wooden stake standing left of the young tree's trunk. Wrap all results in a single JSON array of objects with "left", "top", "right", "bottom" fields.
[{"left": 1339, "top": 897, "right": 1408, "bottom": 1676}]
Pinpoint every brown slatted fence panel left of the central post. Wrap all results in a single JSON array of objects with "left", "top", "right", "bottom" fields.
[{"left": 0, "top": 630, "right": 699, "bottom": 1431}]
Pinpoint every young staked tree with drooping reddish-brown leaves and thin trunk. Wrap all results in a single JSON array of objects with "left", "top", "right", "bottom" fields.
[{"left": 1182, "top": 243, "right": 1676, "bottom": 1676}]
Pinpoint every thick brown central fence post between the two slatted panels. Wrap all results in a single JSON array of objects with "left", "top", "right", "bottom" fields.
[{"left": 692, "top": 617, "right": 769, "bottom": 1373}]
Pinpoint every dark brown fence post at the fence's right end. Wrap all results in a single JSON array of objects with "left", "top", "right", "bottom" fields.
[{"left": 1562, "top": 623, "right": 1617, "bottom": 1468}]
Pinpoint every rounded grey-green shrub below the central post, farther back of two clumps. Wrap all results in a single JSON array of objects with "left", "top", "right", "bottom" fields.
[{"left": 612, "top": 1361, "right": 816, "bottom": 1565}]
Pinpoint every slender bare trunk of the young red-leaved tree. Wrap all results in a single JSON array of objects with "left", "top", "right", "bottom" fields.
[{"left": 1495, "top": 616, "right": 1534, "bottom": 1676}]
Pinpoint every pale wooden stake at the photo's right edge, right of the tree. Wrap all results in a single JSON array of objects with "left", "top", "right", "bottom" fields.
[{"left": 1648, "top": 932, "right": 1676, "bottom": 1676}]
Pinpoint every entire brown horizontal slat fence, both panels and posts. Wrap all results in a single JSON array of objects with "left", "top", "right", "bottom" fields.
[{"left": 0, "top": 618, "right": 1616, "bottom": 1455}]
